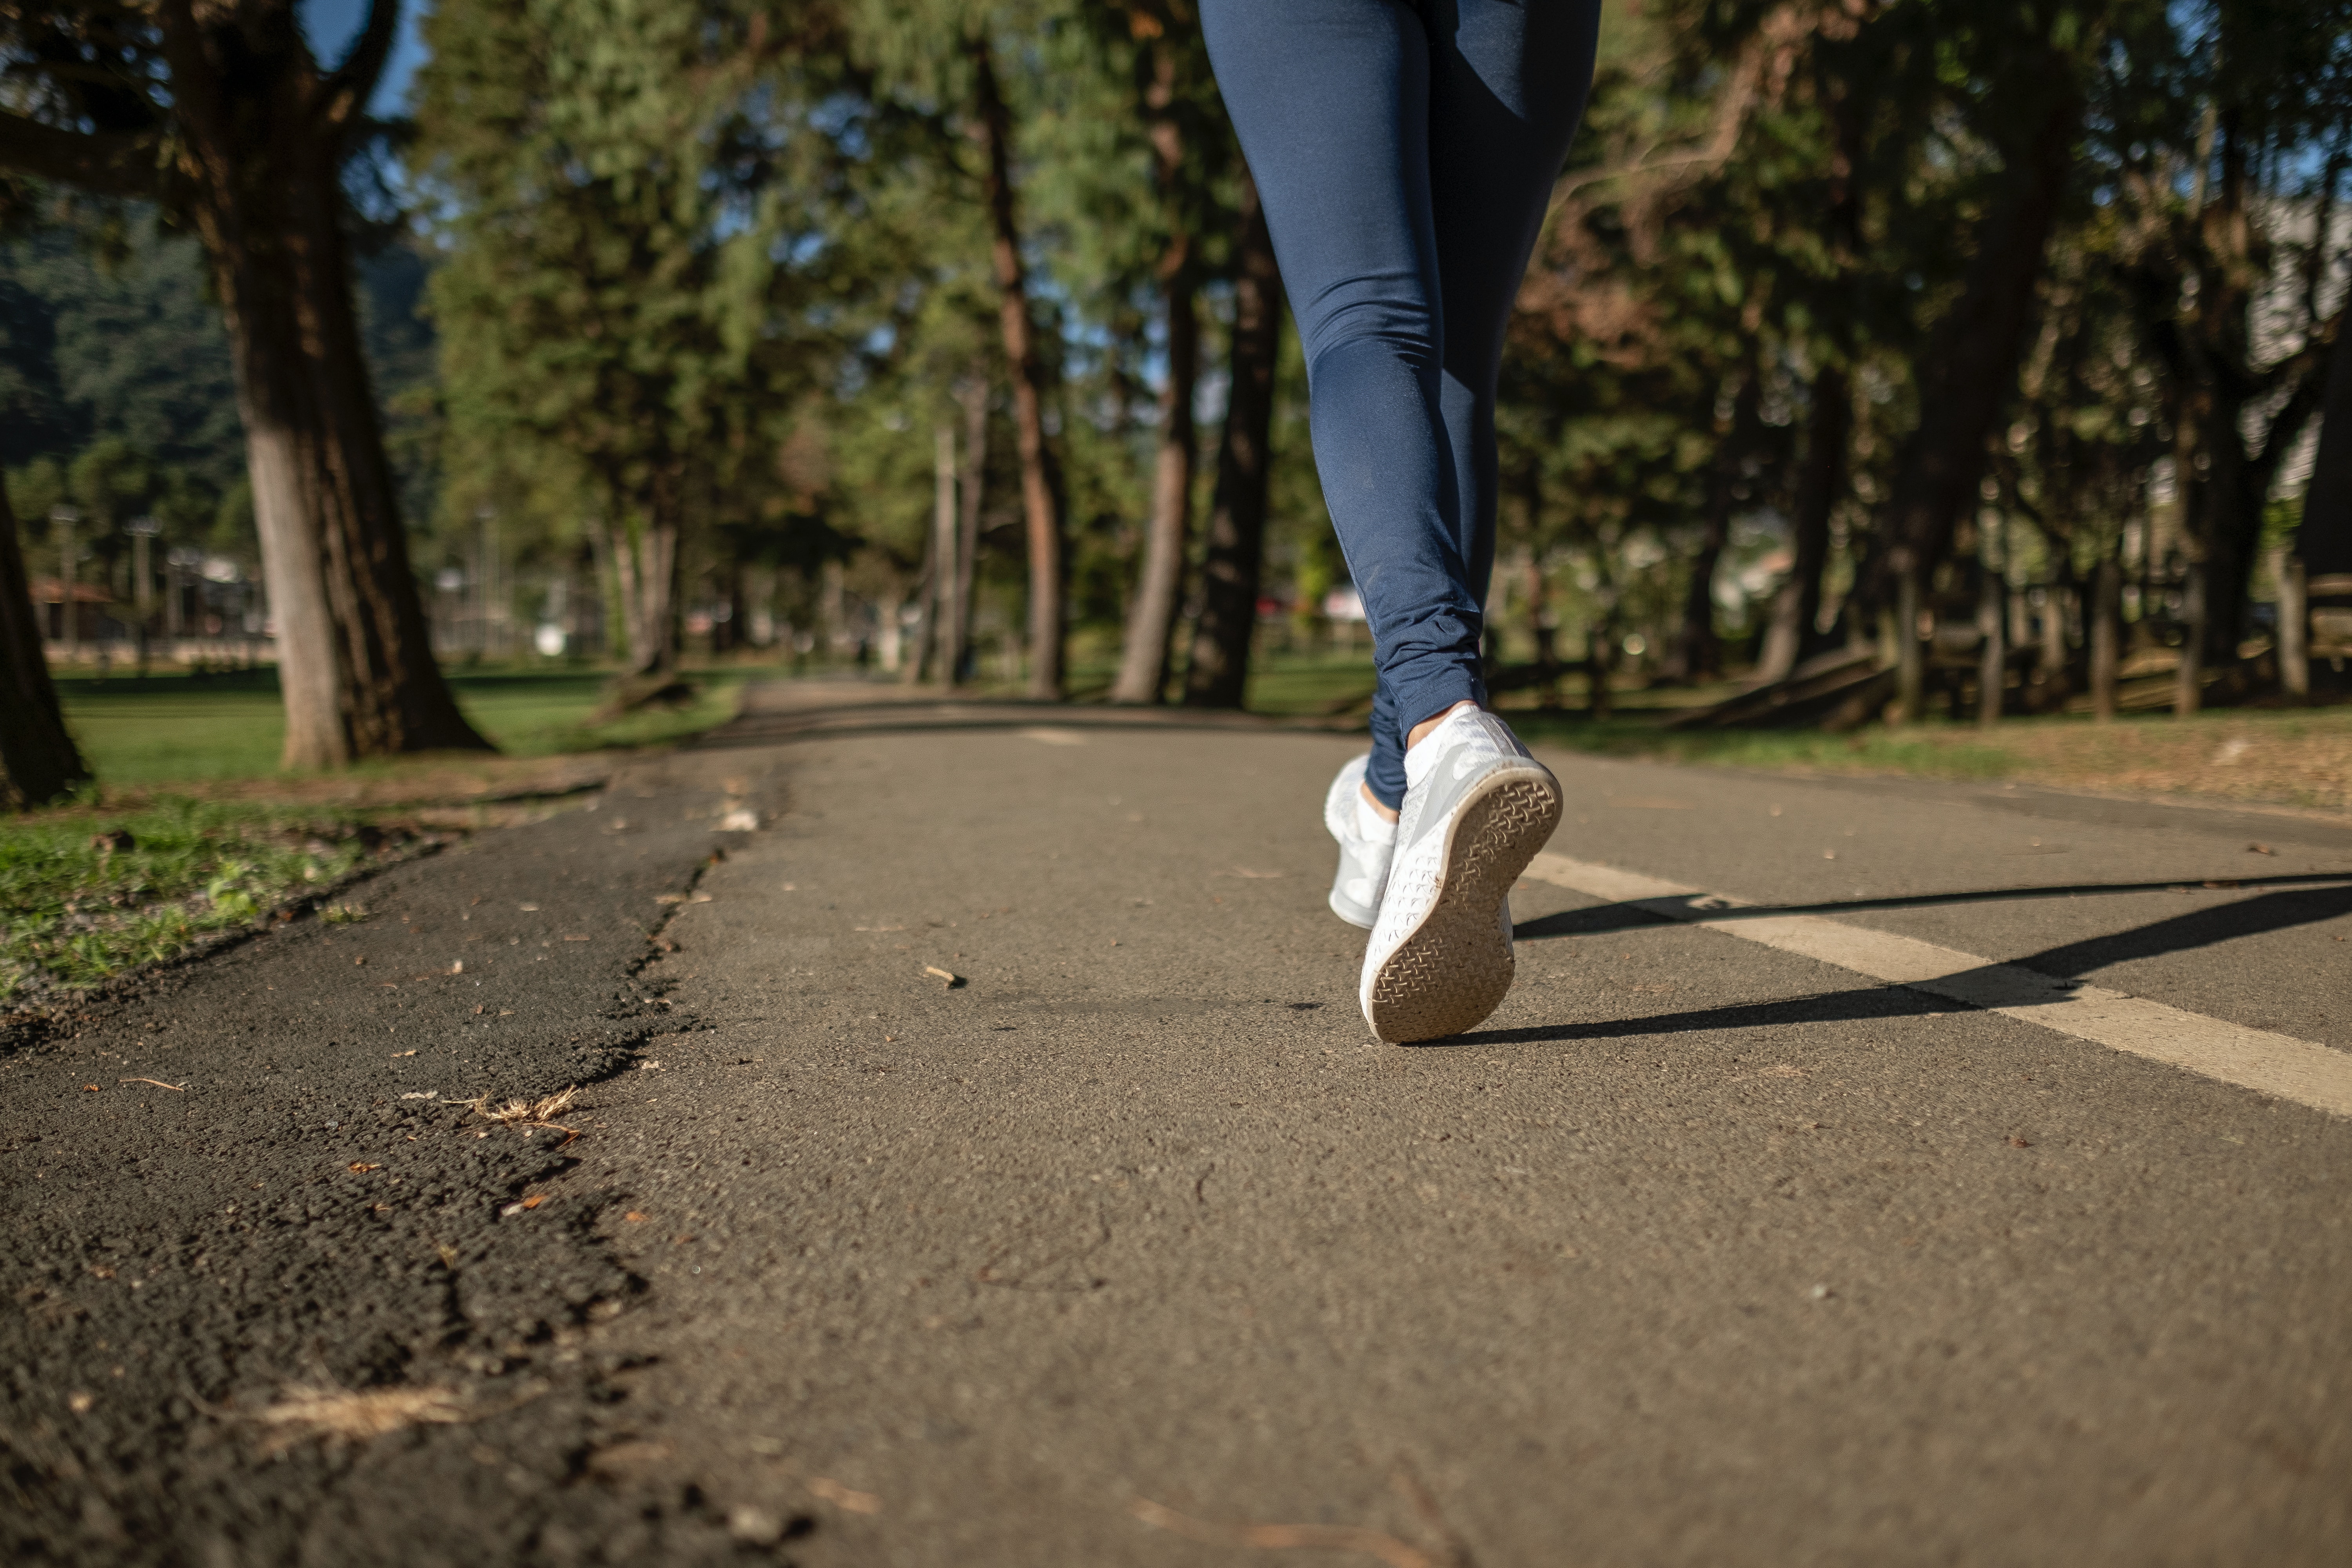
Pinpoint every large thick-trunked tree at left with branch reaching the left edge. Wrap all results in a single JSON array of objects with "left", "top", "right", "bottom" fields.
[{"left": 0, "top": 0, "right": 487, "bottom": 766}]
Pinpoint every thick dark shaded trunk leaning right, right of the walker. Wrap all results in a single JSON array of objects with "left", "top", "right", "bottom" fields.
[{"left": 1867, "top": 69, "right": 2082, "bottom": 621}]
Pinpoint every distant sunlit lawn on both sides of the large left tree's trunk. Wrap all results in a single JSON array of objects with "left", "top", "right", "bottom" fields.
[{"left": 56, "top": 668, "right": 755, "bottom": 788}]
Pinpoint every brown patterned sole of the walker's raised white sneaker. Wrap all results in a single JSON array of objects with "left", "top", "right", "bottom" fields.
[{"left": 1367, "top": 769, "right": 1562, "bottom": 1046}]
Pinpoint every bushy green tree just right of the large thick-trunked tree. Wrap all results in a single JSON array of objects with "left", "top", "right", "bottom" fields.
[{"left": 416, "top": 0, "right": 837, "bottom": 698}]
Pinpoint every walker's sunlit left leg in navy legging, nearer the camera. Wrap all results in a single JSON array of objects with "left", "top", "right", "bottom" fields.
[{"left": 1202, "top": 0, "right": 1484, "bottom": 809}]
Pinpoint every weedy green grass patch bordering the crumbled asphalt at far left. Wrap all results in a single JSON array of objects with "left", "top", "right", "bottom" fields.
[{"left": 0, "top": 802, "right": 395, "bottom": 1004}]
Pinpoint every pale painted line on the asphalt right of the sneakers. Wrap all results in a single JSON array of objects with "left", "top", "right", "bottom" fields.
[{"left": 1526, "top": 853, "right": 2352, "bottom": 1117}]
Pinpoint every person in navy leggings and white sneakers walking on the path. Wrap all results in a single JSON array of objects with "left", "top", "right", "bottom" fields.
[{"left": 1202, "top": 0, "right": 1599, "bottom": 1042}]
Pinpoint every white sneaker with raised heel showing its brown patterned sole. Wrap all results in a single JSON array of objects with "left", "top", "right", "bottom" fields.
[{"left": 1357, "top": 708, "right": 1559, "bottom": 1044}]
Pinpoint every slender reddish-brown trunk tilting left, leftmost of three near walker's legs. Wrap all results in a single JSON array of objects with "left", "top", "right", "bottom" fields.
[{"left": 964, "top": 35, "right": 1065, "bottom": 703}]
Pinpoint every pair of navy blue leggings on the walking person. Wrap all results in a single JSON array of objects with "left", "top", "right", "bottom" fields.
[{"left": 1200, "top": 0, "right": 1599, "bottom": 806}]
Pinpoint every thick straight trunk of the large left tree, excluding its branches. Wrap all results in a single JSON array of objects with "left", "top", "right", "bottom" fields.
[{"left": 158, "top": 2, "right": 489, "bottom": 769}]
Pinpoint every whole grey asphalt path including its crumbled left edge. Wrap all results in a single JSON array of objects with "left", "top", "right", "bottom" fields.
[{"left": 0, "top": 684, "right": 2352, "bottom": 1568}]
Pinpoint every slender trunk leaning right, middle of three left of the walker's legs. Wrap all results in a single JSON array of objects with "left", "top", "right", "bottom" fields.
[{"left": 1110, "top": 42, "right": 1200, "bottom": 703}]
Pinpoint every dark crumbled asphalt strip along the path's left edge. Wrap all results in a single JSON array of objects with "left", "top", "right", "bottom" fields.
[{"left": 0, "top": 790, "right": 800, "bottom": 1568}]
